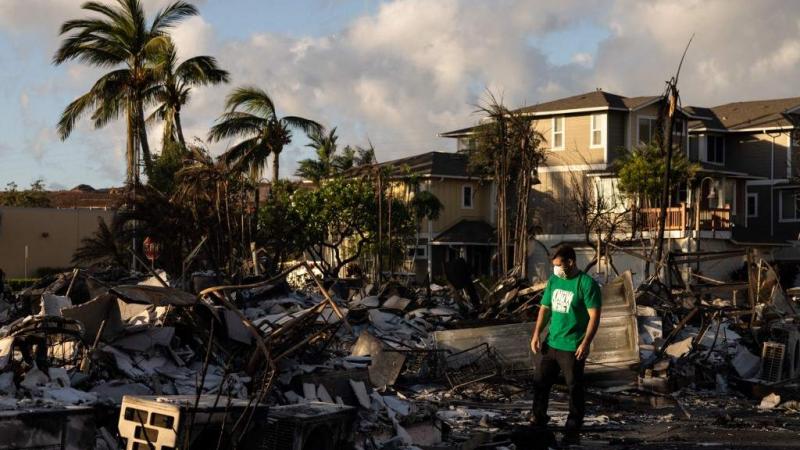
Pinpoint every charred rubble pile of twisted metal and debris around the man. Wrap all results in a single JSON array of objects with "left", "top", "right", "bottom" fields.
[{"left": 0, "top": 255, "right": 800, "bottom": 450}]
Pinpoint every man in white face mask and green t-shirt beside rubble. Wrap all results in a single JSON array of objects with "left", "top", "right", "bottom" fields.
[{"left": 531, "top": 245, "right": 602, "bottom": 442}]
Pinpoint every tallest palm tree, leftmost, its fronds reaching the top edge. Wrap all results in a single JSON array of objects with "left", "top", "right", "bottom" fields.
[{"left": 53, "top": 0, "right": 197, "bottom": 183}]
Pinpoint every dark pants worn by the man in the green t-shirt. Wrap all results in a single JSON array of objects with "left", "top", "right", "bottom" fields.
[{"left": 533, "top": 344, "right": 586, "bottom": 430}]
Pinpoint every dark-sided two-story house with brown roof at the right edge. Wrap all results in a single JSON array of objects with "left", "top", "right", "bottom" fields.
[{"left": 687, "top": 97, "right": 800, "bottom": 244}]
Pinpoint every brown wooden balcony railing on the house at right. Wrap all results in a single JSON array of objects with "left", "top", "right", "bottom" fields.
[{"left": 638, "top": 203, "right": 731, "bottom": 231}]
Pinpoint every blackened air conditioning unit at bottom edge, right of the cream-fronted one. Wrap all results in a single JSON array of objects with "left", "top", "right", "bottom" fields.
[{"left": 258, "top": 402, "right": 356, "bottom": 450}]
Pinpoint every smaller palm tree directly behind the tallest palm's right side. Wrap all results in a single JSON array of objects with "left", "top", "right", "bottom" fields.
[{"left": 148, "top": 39, "right": 230, "bottom": 148}]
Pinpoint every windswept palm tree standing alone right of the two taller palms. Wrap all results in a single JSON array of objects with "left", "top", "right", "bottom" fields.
[{"left": 208, "top": 86, "right": 322, "bottom": 185}]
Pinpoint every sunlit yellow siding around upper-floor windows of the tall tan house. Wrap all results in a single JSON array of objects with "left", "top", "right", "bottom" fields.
[{"left": 533, "top": 112, "right": 605, "bottom": 166}]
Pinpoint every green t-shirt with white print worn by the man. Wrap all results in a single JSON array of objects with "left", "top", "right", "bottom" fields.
[{"left": 541, "top": 272, "right": 602, "bottom": 351}]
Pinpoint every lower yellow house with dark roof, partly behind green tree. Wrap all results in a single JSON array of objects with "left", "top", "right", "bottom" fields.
[{"left": 368, "top": 152, "right": 496, "bottom": 280}]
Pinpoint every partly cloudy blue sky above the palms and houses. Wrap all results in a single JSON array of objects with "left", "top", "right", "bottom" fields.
[{"left": 0, "top": 0, "right": 800, "bottom": 189}]
